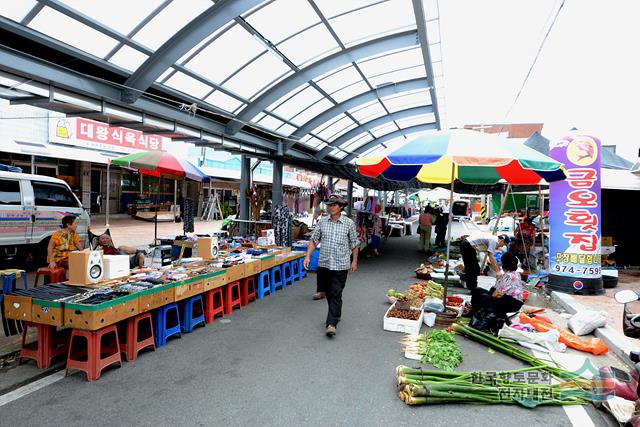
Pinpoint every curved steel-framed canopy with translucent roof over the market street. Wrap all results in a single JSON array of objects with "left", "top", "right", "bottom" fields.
[{"left": 0, "top": 0, "right": 444, "bottom": 163}]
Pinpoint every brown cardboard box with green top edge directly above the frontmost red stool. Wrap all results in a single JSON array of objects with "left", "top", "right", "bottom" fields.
[{"left": 64, "top": 294, "right": 140, "bottom": 331}]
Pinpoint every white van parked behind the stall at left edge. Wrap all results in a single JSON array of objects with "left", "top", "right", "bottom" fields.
[{"left": 0, "top": 172, "right": 89, "bottom": 266}]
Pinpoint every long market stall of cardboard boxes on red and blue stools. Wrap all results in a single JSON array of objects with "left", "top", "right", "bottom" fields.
[{"left": 4, "top": 241, "right": 306, "bottom": 380}]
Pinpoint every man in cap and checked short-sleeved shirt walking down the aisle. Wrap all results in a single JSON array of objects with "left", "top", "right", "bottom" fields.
[{"left": 303, "top": 194, "right": 359, "bottom": 337}]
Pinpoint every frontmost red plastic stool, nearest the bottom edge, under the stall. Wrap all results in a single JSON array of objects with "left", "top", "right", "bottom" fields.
[{"left": 64, "top": 325, "right": 122, "bottom": 381}]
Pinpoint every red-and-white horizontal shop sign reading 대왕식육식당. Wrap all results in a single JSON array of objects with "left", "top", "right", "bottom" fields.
[{"left": 49, "top": 117, "right": 167, "bottom": 153}]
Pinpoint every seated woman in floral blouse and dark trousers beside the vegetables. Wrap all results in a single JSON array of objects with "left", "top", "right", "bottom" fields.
[{"left": 471, "top": 252, "right": 524, "bottom": 315}]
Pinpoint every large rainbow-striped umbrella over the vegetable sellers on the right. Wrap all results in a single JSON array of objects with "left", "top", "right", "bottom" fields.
[{"left": 356, "top": 129, "right": 565, "bottom": 185}]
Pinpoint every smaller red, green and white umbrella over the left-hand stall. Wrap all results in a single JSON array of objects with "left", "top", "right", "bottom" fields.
[{"left": 111, "top": 151, "right": 209, "bottom": 182}]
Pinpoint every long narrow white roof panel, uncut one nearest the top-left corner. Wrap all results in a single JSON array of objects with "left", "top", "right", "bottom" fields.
[{"left": 29, "top": 7, "right": 118, "bottom": 58}]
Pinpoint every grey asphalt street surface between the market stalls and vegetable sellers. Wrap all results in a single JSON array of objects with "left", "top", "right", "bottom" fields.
[{"left": 0, "top": 223, "right": 611, "bottom": 427}]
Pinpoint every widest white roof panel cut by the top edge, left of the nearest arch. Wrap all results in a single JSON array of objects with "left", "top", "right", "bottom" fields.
[{"left": 60, "top": 0, "right": 162, "bottom": 35}]
